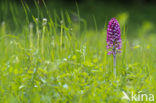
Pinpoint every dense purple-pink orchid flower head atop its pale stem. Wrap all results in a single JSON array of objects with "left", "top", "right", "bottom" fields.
[{"left": 107, "top": 18, "right": 121, "bottom": 55}]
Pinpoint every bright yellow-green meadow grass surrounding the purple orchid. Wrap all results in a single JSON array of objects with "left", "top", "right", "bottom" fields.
[{"left": 0, "top": 0, "right": 156, "bottom": 103}]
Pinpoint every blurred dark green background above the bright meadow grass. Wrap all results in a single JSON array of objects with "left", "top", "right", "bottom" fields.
[{"left": 0, "top": 0, "right": 156, "bottom": 37}]
